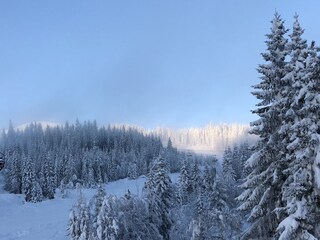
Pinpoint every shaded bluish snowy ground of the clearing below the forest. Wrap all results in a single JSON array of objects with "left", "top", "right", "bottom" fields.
[{"left": 0, "top": 174, "right": 178, "bottom": 240}]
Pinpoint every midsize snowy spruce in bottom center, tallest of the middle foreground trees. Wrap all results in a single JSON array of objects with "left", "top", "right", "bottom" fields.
[{"left": 144, "top": 156, "right": 173, "bottom": 240}]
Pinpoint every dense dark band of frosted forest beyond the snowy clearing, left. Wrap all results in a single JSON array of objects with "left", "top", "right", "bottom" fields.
[{"left": 1, "top": 121, "right": 184, "bottom": 202}]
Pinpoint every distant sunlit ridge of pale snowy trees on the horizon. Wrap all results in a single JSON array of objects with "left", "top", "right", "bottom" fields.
[{"left": 15, "top": 121, "right": 256, "bottom": 156}]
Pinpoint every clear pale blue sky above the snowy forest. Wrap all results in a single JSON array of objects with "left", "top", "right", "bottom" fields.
[{"left": 0, "top": 0, "right": 320, "bottom": 128}]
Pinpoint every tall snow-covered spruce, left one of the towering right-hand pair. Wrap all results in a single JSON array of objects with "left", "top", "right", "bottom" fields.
[{"left": 238, "top": 13, "right": 288, "bottom": 239}]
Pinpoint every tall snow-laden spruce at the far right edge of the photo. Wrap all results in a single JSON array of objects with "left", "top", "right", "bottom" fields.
[{"left": 277, "top": 15, "right": 320, "bottom": 240}]
